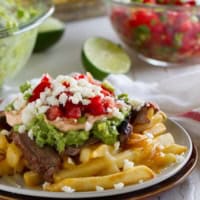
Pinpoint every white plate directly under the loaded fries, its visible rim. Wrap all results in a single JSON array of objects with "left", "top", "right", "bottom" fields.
[{"left": 0, "top": 120, "right": 192, "bottom": 199}]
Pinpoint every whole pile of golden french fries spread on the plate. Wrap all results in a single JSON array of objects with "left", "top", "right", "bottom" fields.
[{"left": 0, "top": 107, "right": 187, "bottom": 192}]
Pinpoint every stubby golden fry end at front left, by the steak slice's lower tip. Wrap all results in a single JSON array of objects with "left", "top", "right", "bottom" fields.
[{"left": 24, "top": 171, "right": 43, "bottom": 187}]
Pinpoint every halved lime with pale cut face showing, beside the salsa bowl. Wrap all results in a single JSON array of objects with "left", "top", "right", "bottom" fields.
[{"left": 82, "top": 37, "right": 131, "bottom": 80}]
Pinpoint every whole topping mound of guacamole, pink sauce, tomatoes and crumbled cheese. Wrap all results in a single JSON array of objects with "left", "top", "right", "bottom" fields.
[{"left": 5, "top": 73, "right": 147, "bottom": 153}]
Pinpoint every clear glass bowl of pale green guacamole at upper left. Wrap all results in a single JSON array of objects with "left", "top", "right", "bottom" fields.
[{"left": 0, "top": 0, "right": 54, "bottom": 87}]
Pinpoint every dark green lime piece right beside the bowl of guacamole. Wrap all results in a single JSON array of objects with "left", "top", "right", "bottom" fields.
[{"left": 34, "top": 17, "right": 65, "bottom": 53}]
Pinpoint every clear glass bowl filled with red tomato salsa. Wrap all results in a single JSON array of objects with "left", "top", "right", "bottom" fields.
[{"left": 105, "top": 0, "right": 200, "bottom": 66}]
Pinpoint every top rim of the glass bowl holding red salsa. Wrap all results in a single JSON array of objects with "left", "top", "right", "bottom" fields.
[{"left": 104, "top": 0, "right": 200, "bottom": 12}]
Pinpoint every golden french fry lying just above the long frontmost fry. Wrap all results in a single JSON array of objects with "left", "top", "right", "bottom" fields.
[{"left": 54, "top": 157, "right": 110, "bottom": 182}]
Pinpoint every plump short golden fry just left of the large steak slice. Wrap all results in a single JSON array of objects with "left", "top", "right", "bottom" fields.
[{"left": 6, "top": 143, "right": 22, "bottom": 168}]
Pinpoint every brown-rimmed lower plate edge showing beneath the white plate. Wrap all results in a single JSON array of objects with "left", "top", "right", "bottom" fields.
[{"left": 0, "top": 145, "right": 198, "bottom": 200}]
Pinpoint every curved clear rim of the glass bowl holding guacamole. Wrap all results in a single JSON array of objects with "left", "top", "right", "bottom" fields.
[{"left": 0, "top": 0, "right": 55, "bottom": 39}]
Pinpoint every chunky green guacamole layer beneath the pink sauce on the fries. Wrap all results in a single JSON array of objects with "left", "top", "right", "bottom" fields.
[{"left": 14, "top": 115, "right": 125, "bottom": 153}]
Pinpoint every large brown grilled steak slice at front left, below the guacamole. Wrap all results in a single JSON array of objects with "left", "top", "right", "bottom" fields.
[{"left": 12, "top": 133, "right": 61, "bottom": 182}]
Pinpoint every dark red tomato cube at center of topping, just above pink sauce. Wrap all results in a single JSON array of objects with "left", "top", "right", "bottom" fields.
[{"left": 65, "top": 101, "right": 81, "bottom": 119}]
